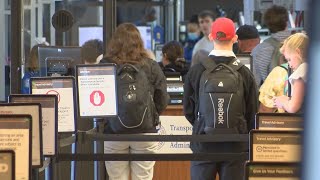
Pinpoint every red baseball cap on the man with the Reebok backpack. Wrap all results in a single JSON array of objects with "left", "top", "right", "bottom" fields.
[{"left": 209, "top": 17, "right": 236, "bottom": 41}]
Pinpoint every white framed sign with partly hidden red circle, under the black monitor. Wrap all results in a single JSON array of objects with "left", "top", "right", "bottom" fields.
[{"left": 31, "top": 77, "right": 75, "bottom": 132}]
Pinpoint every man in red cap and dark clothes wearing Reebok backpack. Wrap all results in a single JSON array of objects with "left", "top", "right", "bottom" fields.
[{"left": 183, "top": 18, "right": 258, "bottom": 180}]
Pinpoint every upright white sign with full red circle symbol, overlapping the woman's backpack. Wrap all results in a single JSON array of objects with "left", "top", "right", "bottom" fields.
[{"left": 77, "top": 64, "right": 117, "bottom": 117}]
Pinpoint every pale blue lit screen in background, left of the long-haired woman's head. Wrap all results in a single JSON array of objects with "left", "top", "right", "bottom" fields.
[{"left": 78, "top": 26, "right": 103, "bottom": 46}]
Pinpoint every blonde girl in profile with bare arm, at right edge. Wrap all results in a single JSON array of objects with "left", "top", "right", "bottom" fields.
[{"left": 273, "top": 33, "right": 309, "bottom": 113}]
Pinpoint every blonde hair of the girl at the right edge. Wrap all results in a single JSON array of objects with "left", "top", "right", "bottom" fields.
[{"left": 280, "top": 33, "right": 309, "bottom": 62}]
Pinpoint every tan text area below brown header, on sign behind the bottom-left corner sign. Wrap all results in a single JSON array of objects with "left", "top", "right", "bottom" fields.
[{"left": 0, "top": 121, "right": 29, "bottom": 180}]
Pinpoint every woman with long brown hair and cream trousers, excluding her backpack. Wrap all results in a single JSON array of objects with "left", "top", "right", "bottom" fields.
[{"left": 100, "top": 23, "right": 169, "bottom": 180}]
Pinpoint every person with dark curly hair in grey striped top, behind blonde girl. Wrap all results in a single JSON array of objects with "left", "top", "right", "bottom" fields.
[{"left": 251, "top": 5, "right": 290, "bottom": 87}]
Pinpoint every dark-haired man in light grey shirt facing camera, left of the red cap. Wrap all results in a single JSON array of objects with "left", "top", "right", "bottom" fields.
[{"left": 192, "top": 10, "right": 215, "bottom": 56}]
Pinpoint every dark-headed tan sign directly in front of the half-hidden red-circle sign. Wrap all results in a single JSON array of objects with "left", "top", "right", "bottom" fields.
[{"left": 9, "top": 95, "right": 58, "bottom": 156}]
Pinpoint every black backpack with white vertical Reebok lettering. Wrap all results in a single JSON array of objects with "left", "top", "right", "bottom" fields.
[{"left": 198, "top": 58, "right": 248, "bottom": 134}]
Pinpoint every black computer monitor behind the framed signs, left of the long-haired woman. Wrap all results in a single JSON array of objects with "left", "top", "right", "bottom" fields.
[{"left": 38, "top": 46, "right": 82, "bottom": 76}]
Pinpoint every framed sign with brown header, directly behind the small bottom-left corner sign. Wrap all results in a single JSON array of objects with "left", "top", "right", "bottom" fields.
[{"left": 0, "top": 117, "right": 31, "bottom": 180}]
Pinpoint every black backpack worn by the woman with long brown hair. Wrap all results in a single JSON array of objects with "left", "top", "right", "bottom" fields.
[{"left": 108, "top": 64, "right": 159, "bottom": 134}]
